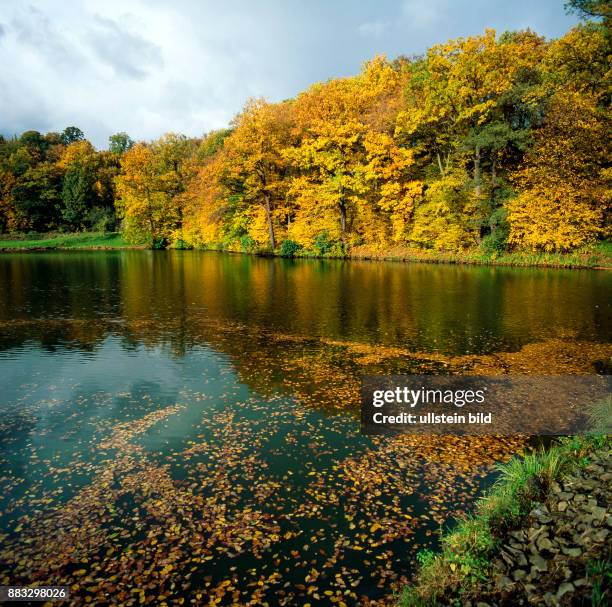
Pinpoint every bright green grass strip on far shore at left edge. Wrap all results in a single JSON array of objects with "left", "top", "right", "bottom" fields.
[{"left": 0, "top": 232, "right": 133, "bottom": 251}]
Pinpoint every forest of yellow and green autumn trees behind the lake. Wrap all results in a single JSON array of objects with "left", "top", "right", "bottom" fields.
[{"left": 0, "top": 0, "right": 612, "bottom": 256}]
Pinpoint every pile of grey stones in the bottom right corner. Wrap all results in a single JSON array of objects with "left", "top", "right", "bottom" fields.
[{"left": 430, "top": 450, "right": 612, "bottom": 607}]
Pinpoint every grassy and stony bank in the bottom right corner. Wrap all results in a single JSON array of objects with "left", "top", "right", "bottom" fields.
[{"left": 399, "top": 394, "right": 612, "bottom": 607}]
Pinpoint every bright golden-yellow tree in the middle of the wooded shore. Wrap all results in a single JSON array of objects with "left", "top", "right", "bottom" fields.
[{"left": 286, "top": 57, "right": 412, "bottom": 248}]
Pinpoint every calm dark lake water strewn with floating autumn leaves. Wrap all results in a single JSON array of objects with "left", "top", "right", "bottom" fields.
[{"left": 0, "top": 251, "right": 612, "bottom": 605}]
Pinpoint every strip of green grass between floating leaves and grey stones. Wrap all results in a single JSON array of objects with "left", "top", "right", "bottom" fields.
[{"left": 398, "top": 434, "right": 610, "bottom": 607}]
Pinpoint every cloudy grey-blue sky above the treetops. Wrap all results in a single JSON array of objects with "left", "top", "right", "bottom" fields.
[{"left": 0, "top": 0, "right": 577, "bottom": 149}]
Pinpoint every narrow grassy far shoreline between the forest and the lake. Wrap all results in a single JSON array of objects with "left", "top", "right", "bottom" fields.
[{"left": 0, "top": 232, "right": 612, "bottom": 271}]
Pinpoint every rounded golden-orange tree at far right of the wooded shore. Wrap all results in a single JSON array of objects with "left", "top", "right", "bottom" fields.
[{"left": 508, "top": 92, "right": 610, "bottom": 251}]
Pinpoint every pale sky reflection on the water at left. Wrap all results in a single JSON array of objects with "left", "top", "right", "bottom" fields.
[{"left": 0, "top": 337, "right": 248, "bottom": 470}]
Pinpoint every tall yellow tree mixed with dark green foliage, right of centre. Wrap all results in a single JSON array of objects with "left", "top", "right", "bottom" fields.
[{"left": 397, "top": 30, "right": 545, "bottom": 248}]
